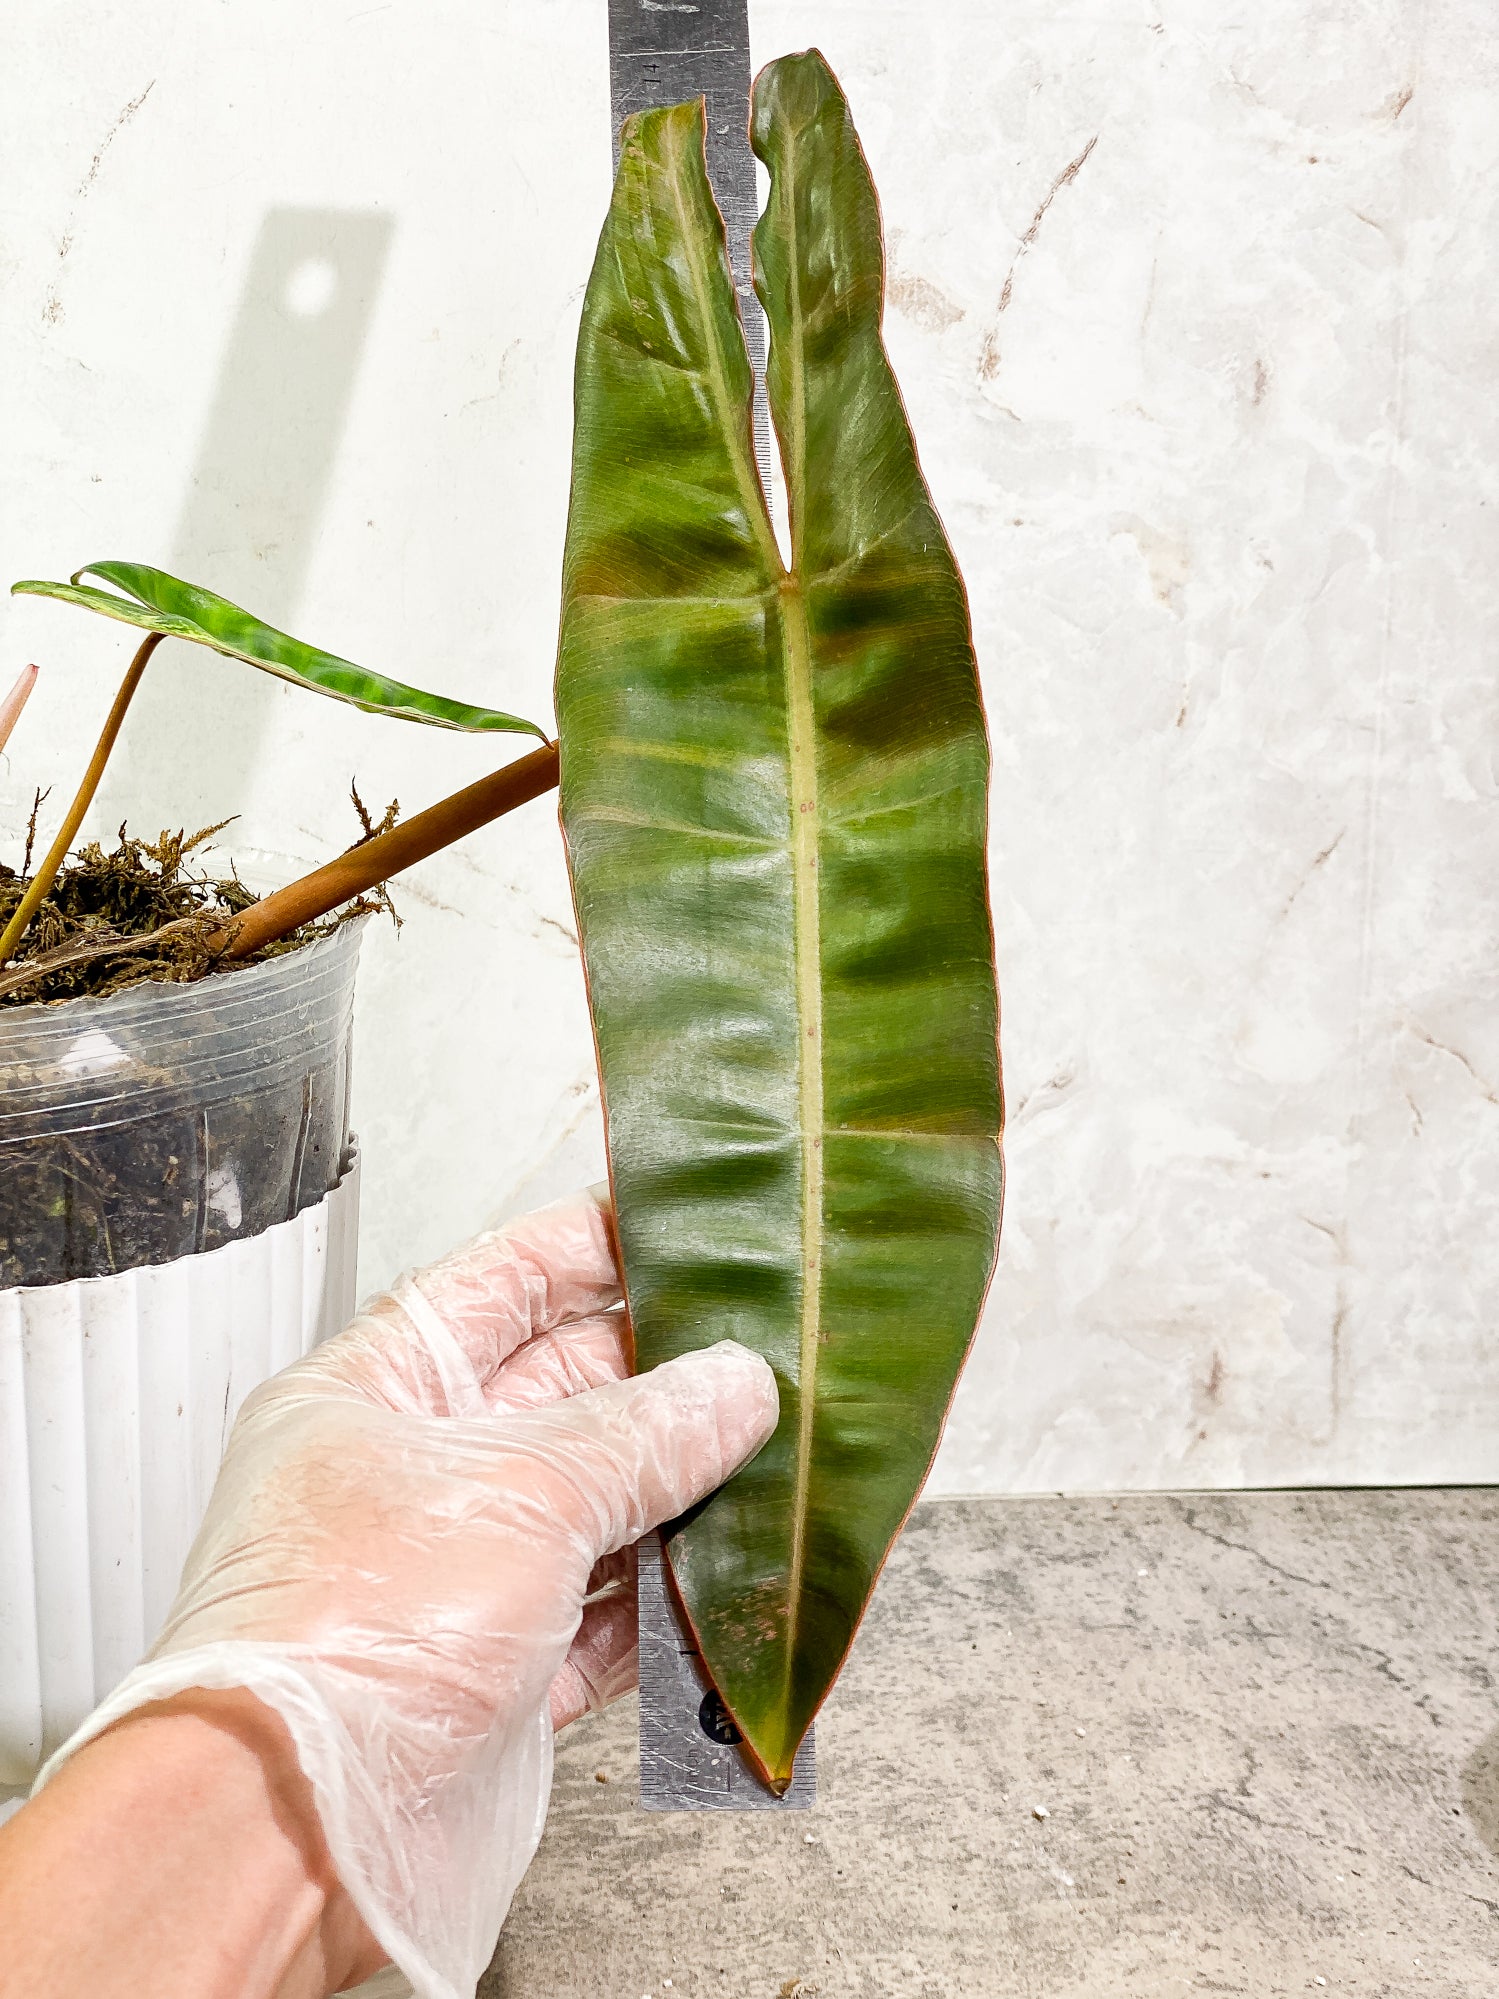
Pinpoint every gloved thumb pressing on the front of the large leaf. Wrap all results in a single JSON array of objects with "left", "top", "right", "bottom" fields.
[{"left": 506, "top": 1339, "right": 779, "bottom": 1561}]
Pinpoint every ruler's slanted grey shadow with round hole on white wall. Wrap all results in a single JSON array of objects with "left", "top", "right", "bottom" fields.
[{"left": 100, "top": 208, "right": 394, "bottom": 832}]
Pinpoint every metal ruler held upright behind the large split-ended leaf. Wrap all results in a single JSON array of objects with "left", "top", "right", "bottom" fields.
[{"left": 610, "top": 0, "right": 817, "bottom": 1811}]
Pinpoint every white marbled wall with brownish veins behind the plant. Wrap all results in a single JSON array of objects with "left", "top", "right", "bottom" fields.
[{"left": 0, "top": 0, "right": 1499, "bottom": 1491}]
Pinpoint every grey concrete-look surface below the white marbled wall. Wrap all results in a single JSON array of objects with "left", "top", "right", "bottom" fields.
[{"left": 482, "top": 1489, "right": 1499, "bottom": 1999}]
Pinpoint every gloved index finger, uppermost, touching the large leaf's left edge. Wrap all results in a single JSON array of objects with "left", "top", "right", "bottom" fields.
[{"left": 292, "top": 1195, "right": 620, "bottom": 1417}]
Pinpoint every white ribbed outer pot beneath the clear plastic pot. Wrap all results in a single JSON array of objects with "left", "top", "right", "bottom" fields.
[{"left": 0, "top": 1151, "right": 360, "bottom": 1787}]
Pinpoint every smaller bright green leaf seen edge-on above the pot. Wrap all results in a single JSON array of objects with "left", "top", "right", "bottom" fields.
[{"left": 10, "top": 562, "right": 548, "bottom": 742}]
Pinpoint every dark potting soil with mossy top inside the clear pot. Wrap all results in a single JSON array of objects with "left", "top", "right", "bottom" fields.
[{"left": 0, "top": 818, "right": 394, "bottom": 1287}]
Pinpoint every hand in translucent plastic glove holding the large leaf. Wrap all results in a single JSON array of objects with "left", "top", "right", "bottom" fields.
[{"left": 38, "top": 1197, "right": 777, "bottom": 1999}]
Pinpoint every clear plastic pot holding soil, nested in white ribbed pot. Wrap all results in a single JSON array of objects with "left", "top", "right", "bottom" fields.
[{"left": 0, "top": 920, "right": 364, "bottom": 1287}]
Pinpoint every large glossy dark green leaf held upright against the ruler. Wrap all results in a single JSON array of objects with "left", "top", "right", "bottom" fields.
[{"left": 558, "top": 52, "right": 1001, "bottom": 1789}]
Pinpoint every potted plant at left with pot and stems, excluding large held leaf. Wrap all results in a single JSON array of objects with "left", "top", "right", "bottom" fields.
[{"left": 0, "top": 562, "right": 556, "bottom": 1783}]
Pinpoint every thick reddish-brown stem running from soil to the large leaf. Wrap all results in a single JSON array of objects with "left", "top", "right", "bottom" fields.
[{"left": 214, "top": 744, "right": 558, "bottom": 958}]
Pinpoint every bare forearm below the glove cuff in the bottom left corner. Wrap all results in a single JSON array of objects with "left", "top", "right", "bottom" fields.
[{"left": 0, "top": 1693, "right": 380, "bottom": 1999}]
